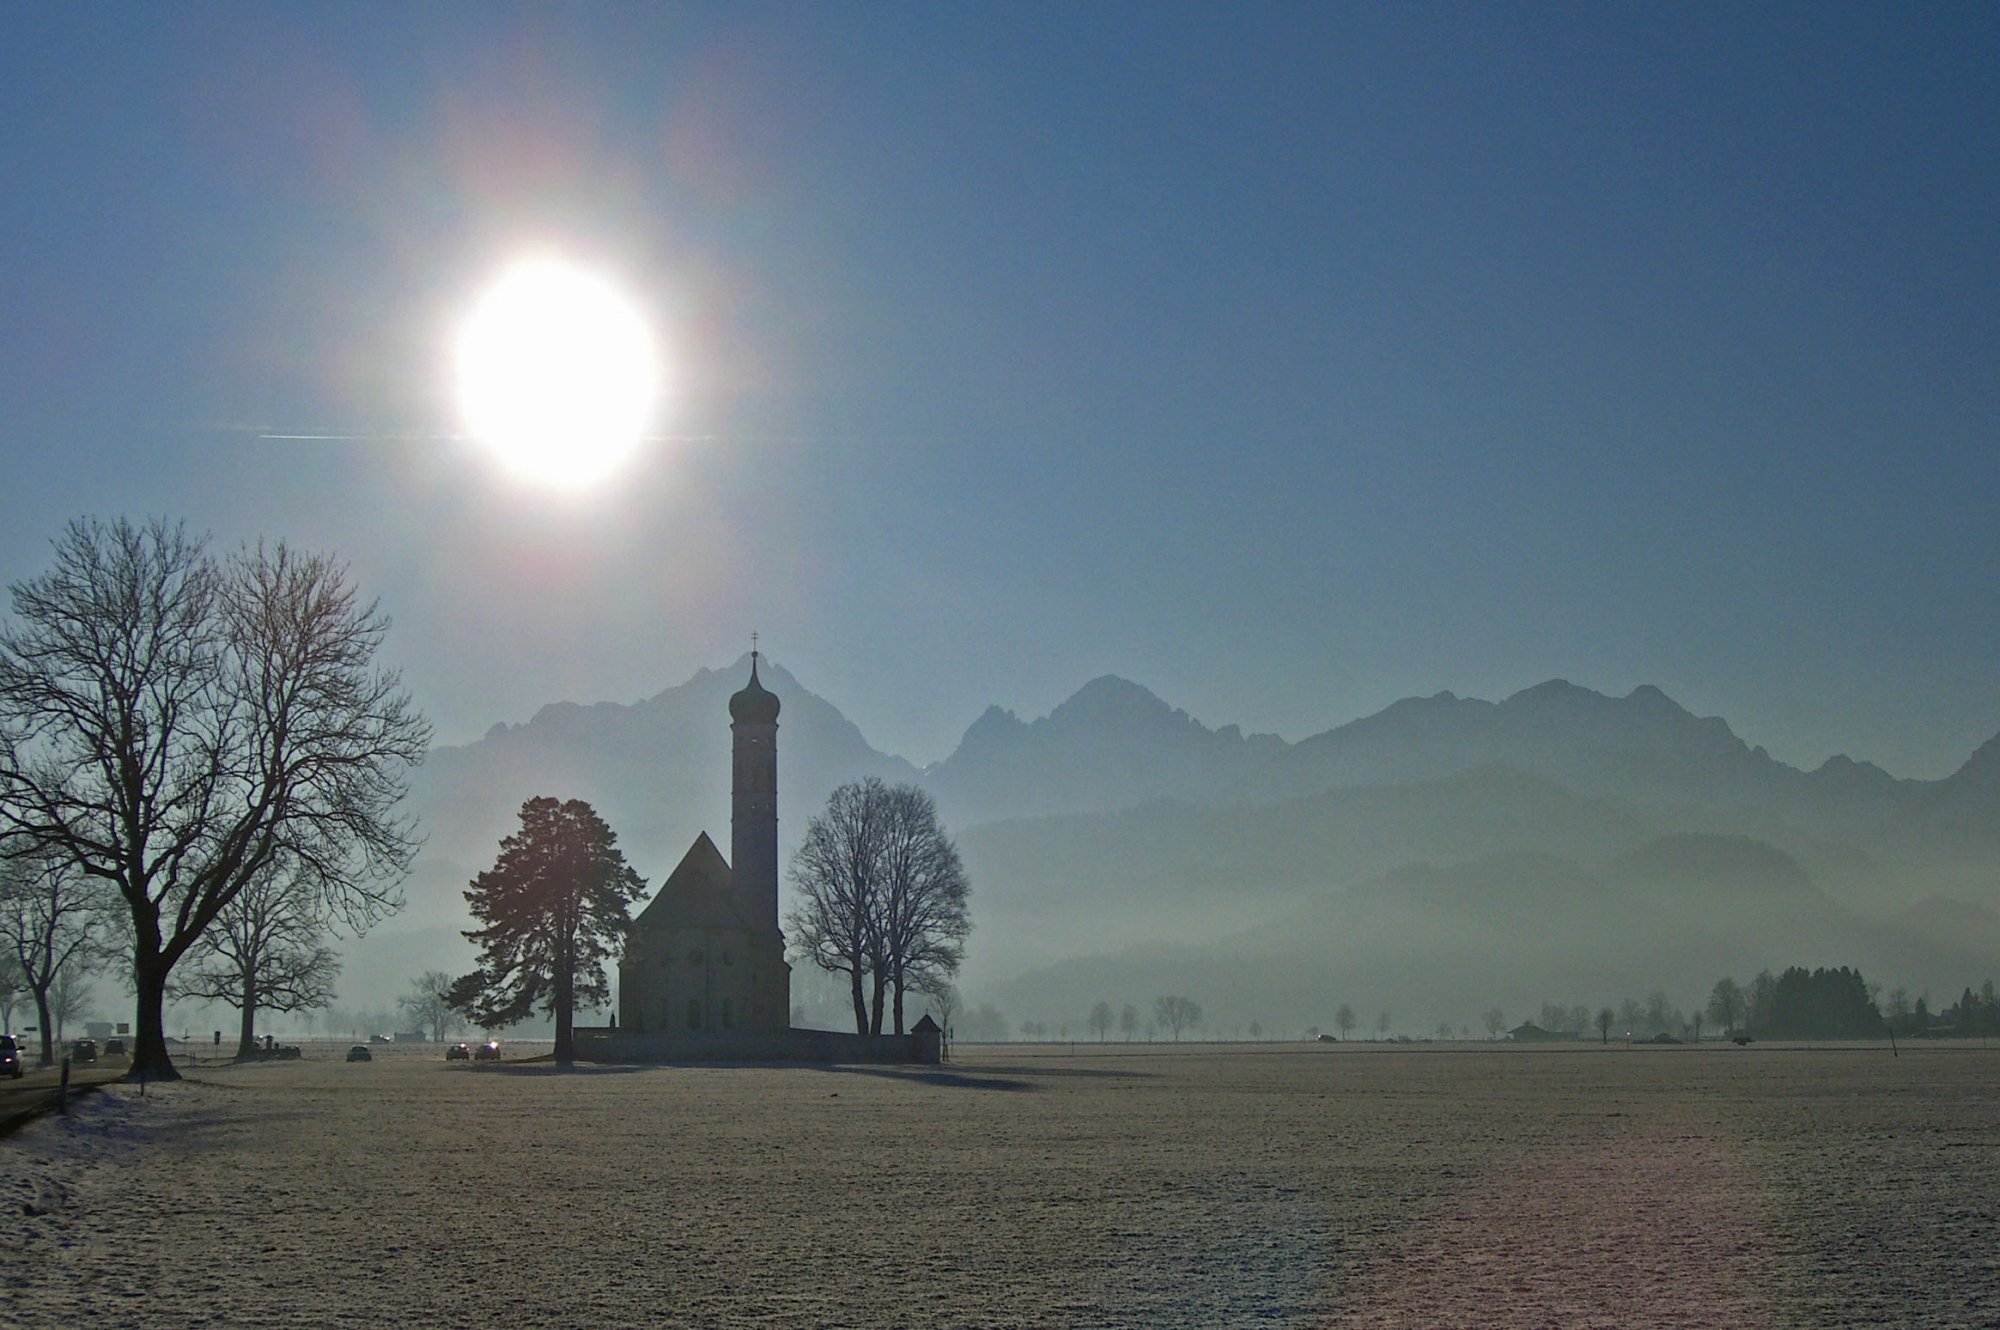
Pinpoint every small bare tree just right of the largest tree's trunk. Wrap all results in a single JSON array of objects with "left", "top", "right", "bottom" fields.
[{"left": 170, "top": 864, "right": 340, "bottom": 1058}]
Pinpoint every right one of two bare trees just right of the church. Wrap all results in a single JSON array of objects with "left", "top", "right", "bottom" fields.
[{"left": 872, "top": 786, "right": 972, "bottom": 1034}]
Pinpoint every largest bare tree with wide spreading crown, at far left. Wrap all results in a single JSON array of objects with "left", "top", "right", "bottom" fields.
[{"left": 0, "top": 518, "right": 430, "bottom": 1078}]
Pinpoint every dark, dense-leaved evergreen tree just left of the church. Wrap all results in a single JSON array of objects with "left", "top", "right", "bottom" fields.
[{"left": 452, "top": 798, "right": 646, "bottom": 1064}]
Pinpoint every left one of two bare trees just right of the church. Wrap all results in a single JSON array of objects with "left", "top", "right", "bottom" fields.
[{"left": 786, "top": 776, "right": 888, "bottom": 1034}]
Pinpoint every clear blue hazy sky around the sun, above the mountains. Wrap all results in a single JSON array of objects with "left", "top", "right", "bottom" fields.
[{"left": 0, "top": 4, "right": 2000, "bottom": 776}]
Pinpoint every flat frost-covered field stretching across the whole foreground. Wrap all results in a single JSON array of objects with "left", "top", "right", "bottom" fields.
[{"left": 0, "top": 1044, "right": 2000, "bottom": 1328}]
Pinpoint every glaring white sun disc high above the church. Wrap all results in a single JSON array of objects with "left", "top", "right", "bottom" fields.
[{"left": 456, "top": 258, "right": 660, "bottom": 490}]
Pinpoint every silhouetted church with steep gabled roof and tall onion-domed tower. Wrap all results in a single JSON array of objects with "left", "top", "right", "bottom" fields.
[{"left": 618, "top": 652, "right": 792, "bottom": 1036}]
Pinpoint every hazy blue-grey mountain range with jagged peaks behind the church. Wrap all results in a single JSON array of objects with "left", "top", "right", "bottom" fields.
[{"left": 336, "top": 660, "right": 2000, "bottom": 1020}]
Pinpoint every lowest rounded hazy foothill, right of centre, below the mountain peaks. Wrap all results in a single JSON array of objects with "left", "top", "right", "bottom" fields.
[{"left": 996, "top": 836, "right": 1904, "bottom": 1034}]
